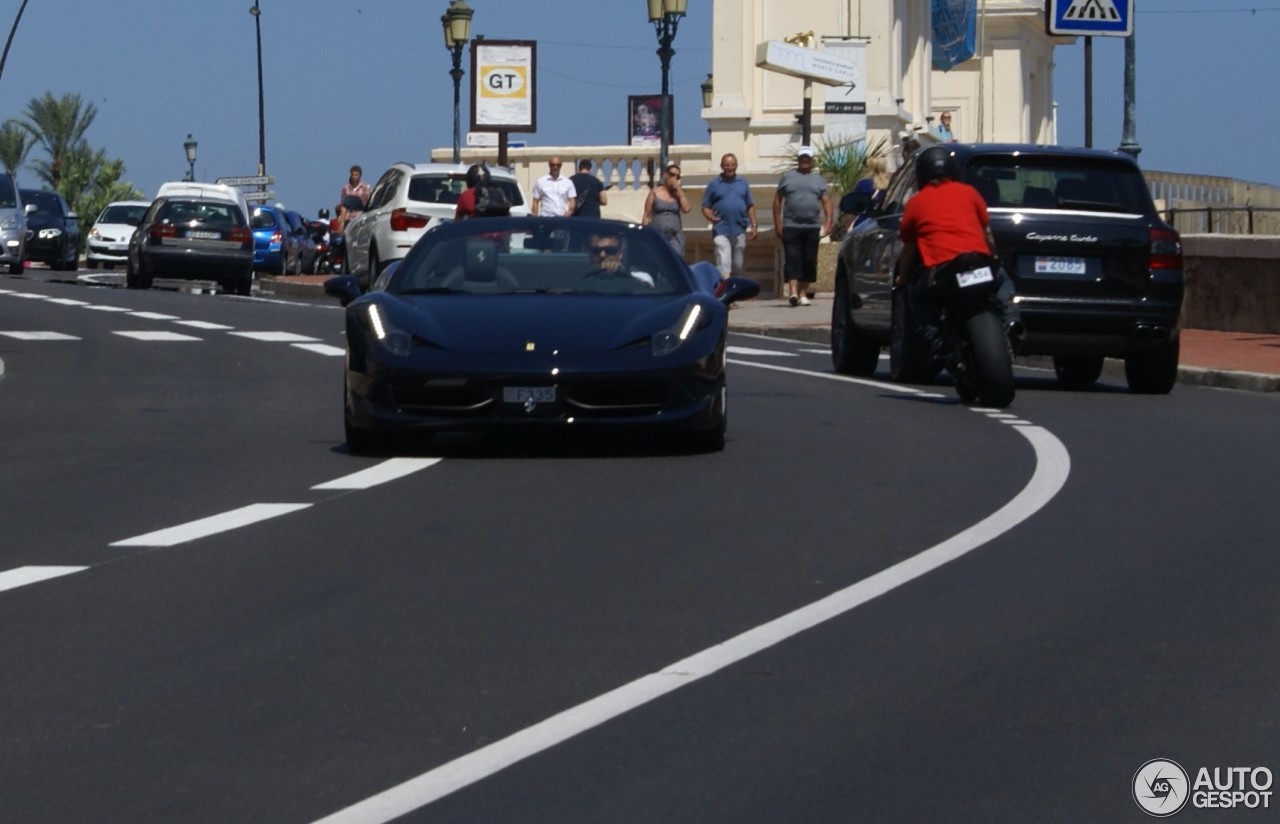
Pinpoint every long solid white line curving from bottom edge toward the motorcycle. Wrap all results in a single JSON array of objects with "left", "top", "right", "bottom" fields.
[{"left": 315, "top": 365, "right": 1071, "bottom": 824}]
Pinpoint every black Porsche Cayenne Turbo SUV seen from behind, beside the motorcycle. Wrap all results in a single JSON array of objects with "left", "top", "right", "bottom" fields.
[{"left": 831, "top": 143, "right": 1184, "bottom": 394}]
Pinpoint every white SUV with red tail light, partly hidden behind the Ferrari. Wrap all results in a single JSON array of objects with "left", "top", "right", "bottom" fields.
[{"left": 343, "top": 162, "right": 529, "bottom": 288}]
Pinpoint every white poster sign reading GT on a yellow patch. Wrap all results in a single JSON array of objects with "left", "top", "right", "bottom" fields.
[{"left": 471, "top": 40, "right": 538, "bottom": 132}]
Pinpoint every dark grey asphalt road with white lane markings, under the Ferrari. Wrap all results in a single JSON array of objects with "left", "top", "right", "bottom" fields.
[{"left": 0, "top": 278, "right": 1280, "bottom": 824}]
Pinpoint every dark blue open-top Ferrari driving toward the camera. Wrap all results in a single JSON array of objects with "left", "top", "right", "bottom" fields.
[{"left": 325, "top": 218, "right": 759, "bottom": 452}]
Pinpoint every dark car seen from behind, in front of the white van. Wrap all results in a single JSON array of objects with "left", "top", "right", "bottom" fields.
[{"left": 125, "top": 196, "right": 253, "bottom": 294}]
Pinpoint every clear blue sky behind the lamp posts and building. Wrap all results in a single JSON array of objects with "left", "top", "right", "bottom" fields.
[{"left": 0, "top": 0, "right": 1280, "bottom": 215}]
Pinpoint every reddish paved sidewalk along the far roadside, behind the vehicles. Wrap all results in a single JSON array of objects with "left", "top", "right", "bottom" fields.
[{"left": 259, "top": 275, "right": 1280, "bottom": 392}]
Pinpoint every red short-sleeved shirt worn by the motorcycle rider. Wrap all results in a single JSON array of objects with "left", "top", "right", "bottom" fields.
[{"left": 897, "top": 180, "right": 991, "bottom": 266}]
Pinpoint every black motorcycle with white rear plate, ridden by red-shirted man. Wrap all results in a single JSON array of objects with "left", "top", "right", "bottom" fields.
[{"left": 890, "top": 253, "right": 1016, "bottom": 408}]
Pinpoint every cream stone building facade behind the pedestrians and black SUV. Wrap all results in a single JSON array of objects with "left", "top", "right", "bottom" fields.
[{"left": 703, "top": 0, "right": 1070, "bottom": 171}]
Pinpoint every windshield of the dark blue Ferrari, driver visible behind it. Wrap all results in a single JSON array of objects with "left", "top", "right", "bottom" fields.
[{"left": 387, "top": 219, "right": 691, "bottom": 296}]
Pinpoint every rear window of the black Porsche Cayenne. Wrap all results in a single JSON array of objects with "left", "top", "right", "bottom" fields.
[{"left": 964, "top": 155, "right": 1152, "bottom": 215}]
